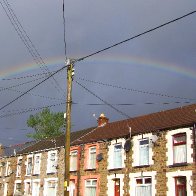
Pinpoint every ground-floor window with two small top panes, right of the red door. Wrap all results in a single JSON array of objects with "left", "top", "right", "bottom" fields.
[{"left": 135, "top": 177, "right": 152, "bottom": 196}]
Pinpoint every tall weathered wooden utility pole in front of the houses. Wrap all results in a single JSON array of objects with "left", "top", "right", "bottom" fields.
[{"left": 64, "top": 59, "right": 73, "bottom": 196}]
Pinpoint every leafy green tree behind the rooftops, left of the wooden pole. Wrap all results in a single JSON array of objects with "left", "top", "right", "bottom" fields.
[{"left": 27, "top": 108, "right": 65, "bottom": 140}]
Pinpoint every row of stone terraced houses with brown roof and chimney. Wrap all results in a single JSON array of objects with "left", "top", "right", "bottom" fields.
[{"left": 0, "top": 104, "right": 196, "bottom": 196}]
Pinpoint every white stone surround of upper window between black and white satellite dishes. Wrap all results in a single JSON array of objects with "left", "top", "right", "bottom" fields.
[{"left": 132, "top": 133, "right": 154, "bottom": 167}]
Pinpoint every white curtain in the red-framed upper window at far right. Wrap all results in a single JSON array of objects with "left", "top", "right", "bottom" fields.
[{"left": 174, "top": 145, "right": 187, "bottom": 163}]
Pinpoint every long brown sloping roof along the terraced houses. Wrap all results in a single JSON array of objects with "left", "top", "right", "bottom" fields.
[{"left": 18, "top": 104, "right": 196, "bottom": 154}]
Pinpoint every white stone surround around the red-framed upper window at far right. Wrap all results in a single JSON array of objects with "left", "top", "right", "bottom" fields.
[{"left": 166, "top": 128, "right": 193, "bottom": 166}]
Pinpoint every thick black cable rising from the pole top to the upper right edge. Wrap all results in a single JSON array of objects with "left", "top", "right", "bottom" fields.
[{"left": 75, "top": 11, "right": 196, "bottom": 62}]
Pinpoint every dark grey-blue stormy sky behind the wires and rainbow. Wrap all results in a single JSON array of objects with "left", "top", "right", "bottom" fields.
[{"left": 0, "top": 0, "right": 196, "bottom": 146}]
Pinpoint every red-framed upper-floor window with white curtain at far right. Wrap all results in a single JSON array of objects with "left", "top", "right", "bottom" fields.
[{"left": 173, "top": 133, "right": 187, "bottom": 164}]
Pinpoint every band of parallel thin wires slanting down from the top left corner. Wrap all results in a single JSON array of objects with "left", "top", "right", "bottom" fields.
[{"left": 0, "top": 0, "right": 62, "bottom": 92}]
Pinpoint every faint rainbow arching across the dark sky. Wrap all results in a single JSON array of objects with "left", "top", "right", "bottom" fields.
[{"left": 0, "top": 55, "right": 196, "bottom": 79}]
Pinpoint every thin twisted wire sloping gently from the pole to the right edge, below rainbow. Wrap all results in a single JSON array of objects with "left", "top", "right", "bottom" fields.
[{"left": 77, "top": 77, "right": 196, "bottom": 101}]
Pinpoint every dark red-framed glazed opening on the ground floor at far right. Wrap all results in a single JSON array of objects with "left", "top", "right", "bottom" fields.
[{"left": 175, "top": 176, "right": 187, "bottom": 196}]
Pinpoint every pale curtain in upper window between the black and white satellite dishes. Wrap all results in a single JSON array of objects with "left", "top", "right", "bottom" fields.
[{"left": 139, "top": 145, "right": 149, "bottom": 165}]
